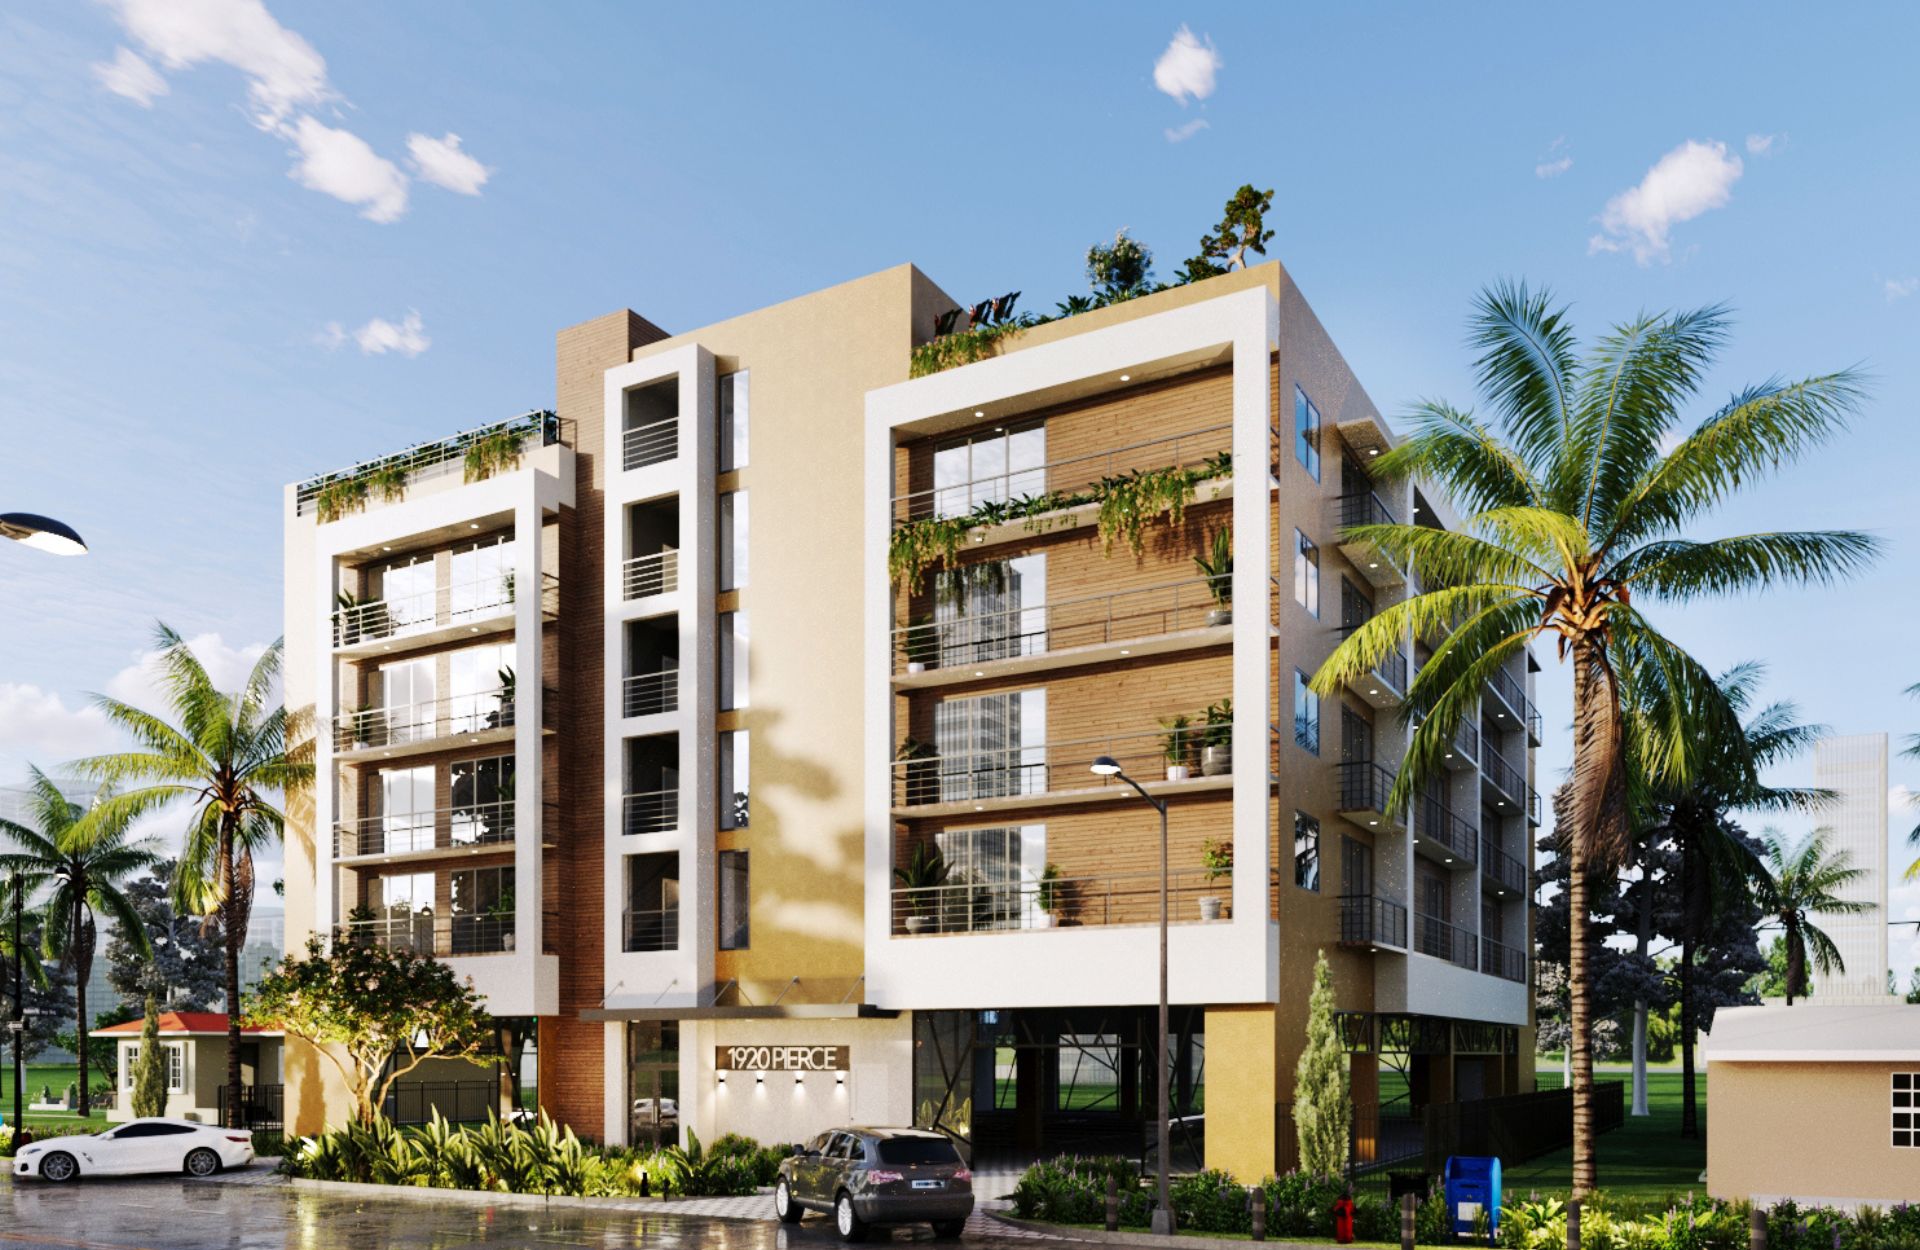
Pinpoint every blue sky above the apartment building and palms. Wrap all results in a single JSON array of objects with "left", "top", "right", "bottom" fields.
[{"left": 0, "top": 0, "right": 1920, "bottom": 967}]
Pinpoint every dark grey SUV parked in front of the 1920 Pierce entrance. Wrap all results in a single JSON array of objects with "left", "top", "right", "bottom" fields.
[{"left": 774, "top": 1129, "right": 973, "bottom": 1240}]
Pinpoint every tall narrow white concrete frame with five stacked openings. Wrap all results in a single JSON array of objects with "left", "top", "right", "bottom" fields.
[{"left": 601, "top": 344, "right": 718, "bottom": 1144}]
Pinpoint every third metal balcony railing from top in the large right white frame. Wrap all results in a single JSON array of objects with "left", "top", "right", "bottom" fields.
[{"left": 893, "top": 726, "right": 1233, "bottom": 806}]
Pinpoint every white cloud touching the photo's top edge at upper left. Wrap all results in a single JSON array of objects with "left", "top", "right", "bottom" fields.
[{"left": 102, "top": 0, "right": 334, "bottom": 131}]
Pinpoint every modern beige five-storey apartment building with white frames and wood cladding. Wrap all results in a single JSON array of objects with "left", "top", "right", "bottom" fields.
[{"left": 286, "top": 263, "right": 1540, "bottom": 1177}]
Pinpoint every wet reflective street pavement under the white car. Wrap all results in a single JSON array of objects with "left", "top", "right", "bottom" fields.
[{"left": 0, "top": 1173, "right": 1071, "bottom": 1250}]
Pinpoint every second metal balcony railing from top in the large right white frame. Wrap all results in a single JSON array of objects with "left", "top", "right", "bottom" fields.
[{"left": 893, "top": 578, "right": 1217, "bottom": 672}]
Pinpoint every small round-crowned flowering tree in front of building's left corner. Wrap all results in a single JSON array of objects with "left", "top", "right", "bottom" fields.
[{"left": 248, "top": 933, "right": 493, "bottom": 1123}]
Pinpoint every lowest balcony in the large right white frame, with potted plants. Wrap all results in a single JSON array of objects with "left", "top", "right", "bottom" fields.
[{"left": 891, "top": 868, "right": 1233, "bottom": 937}]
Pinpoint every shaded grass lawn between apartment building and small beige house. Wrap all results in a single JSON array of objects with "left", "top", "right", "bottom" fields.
[{"left": 1501, "top": 1066, "right": 1707, "bottom": 1206}]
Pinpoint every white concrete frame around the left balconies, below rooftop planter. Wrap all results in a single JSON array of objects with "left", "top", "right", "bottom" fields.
[{"left": 311, "top": 444, "right": 574, "bottom": 1016}]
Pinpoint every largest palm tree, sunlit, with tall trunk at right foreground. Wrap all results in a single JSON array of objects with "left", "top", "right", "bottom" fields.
[{"left": 1313, "top": 284, "right": 1878, "bottom": 1194}]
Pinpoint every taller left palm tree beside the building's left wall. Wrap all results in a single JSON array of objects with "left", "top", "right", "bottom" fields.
[{"left": 77, "top": 624, "right": 313, "bottom": 1127}]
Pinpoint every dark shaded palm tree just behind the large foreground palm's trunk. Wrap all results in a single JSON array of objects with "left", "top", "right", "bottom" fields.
[{"left": 1636, "top": 662, "right": 1830, "bottom": 1137}]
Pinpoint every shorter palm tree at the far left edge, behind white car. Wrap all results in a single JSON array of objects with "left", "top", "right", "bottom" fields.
[{"left": 0, "top": 768, "right": 159, "bottom": 1116}]
